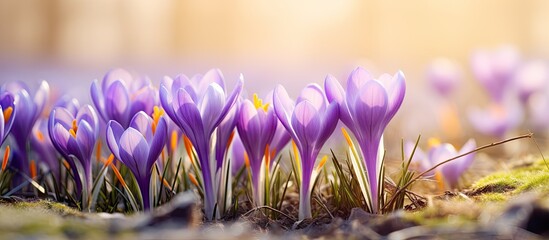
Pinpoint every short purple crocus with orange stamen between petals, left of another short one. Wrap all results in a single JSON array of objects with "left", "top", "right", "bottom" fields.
[{"left": 48, "top": 105, "right": 99, "bottom": 198}]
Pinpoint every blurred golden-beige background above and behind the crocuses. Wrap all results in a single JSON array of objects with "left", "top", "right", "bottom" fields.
[{"left": 0, "top": 0, "right": 549, "bottom": 145}]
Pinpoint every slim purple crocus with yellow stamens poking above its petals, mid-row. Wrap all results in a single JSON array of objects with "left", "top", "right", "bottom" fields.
[{"left": 236, "top": 95, "right": 278, "bottom": 205}]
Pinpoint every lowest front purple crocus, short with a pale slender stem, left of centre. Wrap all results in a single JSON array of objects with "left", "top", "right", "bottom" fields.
[{"left": 107, "top": 111, "right": 168, "bottom": 211}]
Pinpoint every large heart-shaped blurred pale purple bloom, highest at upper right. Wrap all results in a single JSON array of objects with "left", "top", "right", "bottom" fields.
[{"left": 471, "top": 46, "right": 520, "bottom": 102}]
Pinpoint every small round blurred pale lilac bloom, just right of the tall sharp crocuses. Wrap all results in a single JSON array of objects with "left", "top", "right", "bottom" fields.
[{"left": 427, "top": 58, "right": 462, "bottom": 96}]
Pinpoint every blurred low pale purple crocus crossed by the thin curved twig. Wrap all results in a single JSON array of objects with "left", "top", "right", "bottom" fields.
[{"left": 404, "top": 139, "right": 477, "bottom": 189}]
